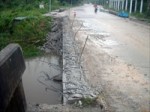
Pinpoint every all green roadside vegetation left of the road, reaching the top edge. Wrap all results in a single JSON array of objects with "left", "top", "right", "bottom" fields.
[{"left": 0, "top": 0, "right": 82, "bottom": 58}]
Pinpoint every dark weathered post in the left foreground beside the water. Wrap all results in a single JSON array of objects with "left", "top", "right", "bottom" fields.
[{"left": 0, "top": 44, "right": 26, "bottom": 112}]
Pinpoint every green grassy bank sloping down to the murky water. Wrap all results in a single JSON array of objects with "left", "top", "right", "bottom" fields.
[{"left": 0, "top": 5, "right": 51, "bottom": 57}]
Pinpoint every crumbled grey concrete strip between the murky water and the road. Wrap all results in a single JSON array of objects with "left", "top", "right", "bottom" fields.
[{"left": 63, "top": 18, "right": 97, "bottom": 104}]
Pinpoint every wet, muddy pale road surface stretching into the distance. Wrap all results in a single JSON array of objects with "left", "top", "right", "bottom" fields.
[{"left": 70, "top": 5, "right": 150, "bottom": 112}]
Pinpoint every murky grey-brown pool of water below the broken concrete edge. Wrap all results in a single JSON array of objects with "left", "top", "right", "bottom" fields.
[{"left": 23, "top": 55, "right": 62, "bottom": 104}]
